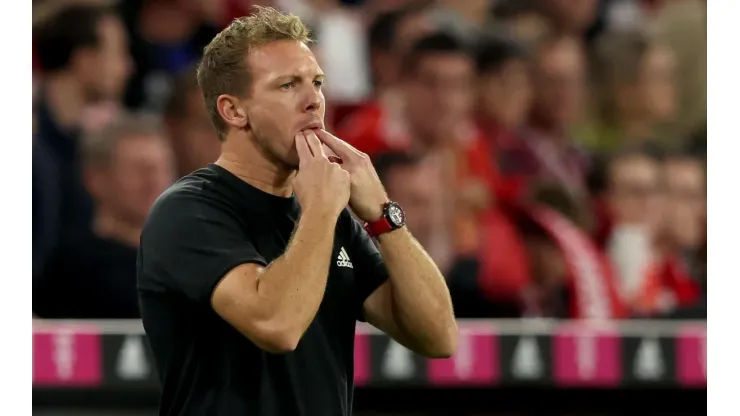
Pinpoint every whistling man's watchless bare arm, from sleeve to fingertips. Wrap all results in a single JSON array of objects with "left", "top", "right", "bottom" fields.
[{"left": 211, "top": 133, "right": 350, "bottom": 352}]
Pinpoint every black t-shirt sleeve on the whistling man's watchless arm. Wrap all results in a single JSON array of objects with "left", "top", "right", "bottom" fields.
[{"left": 137, "top": 194, "right": 266, "bottom": 305}]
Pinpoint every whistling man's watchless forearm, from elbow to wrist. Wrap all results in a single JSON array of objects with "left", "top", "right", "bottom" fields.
[{"left": 257, "top": 212, "right": 337, "bottom": 337}]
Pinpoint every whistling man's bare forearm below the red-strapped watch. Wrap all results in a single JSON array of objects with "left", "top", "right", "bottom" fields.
[{"left": 378, "top": 228, "right": 457, "bottom": 355}]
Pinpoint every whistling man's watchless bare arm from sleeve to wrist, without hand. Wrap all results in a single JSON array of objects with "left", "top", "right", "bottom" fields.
[{"left": 211, "top": 211, "right": 335, "bottom": 353}]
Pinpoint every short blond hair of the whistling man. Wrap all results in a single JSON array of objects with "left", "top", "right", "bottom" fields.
[{"left": 198, "top": 6, "right": 311, "bottom": 140}]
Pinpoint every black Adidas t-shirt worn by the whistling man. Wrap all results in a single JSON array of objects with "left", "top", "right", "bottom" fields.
[{"left": 137, "top": 165, "right": 388, "bottom": 416}]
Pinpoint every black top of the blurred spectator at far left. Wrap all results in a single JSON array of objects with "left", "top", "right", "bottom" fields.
[{"left": 33, "top": 235, "right": 139, "bottom": 319}]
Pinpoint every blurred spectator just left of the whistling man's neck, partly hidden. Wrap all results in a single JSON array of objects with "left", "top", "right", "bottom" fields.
[{"left": 164, "top": 68, "right": 221, "bottom": 177}]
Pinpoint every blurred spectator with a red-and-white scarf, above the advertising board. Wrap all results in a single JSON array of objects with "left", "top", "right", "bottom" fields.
[{"left": 517, "top": 186, "right": 626, "bottom": 318}]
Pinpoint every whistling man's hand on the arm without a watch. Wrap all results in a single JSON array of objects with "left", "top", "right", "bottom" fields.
[{"left": 293, "top": 132, "right": 350, "bottom": 219}]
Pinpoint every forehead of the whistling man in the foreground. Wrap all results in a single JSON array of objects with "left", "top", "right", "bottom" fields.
[{"left": 247, "top": 41, "right": 321, "bottom": 78}]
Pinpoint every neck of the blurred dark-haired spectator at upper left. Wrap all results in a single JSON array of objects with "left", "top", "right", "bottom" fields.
[{"left": 44, "top": 74, "right": 85, "bottom": 127}]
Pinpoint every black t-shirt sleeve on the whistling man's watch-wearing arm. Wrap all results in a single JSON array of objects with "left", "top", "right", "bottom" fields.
[{"left": 345, "top": 211, "right": 388, "bottom": 322}]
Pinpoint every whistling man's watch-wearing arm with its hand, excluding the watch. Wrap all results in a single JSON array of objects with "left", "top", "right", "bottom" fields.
[{"left": 312, "top": 130, "right": 457, "bottom": 358}]
